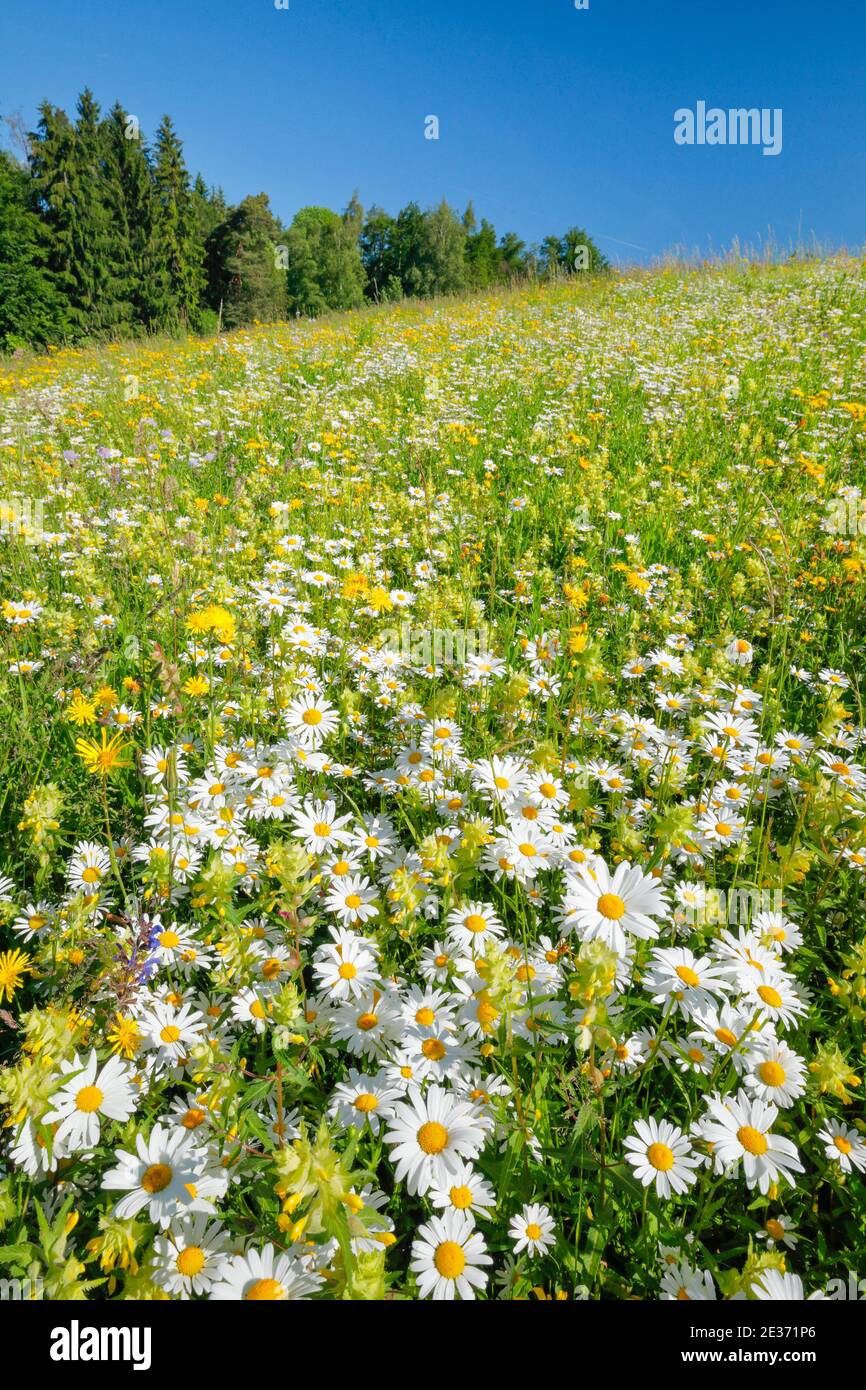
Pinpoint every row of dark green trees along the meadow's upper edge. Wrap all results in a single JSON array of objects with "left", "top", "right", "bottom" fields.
[{"left": 0, "top": 90, "right": 607, "bottom": 352}]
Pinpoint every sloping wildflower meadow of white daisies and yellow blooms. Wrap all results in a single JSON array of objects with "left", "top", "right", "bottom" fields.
[{"left": 0, "top": 255, "right": 866, "bottom": 1302}]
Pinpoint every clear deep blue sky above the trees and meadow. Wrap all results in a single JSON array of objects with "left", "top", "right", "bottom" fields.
[{"left": 0, "top": 0, "right": 866, "bottom": 260}]
